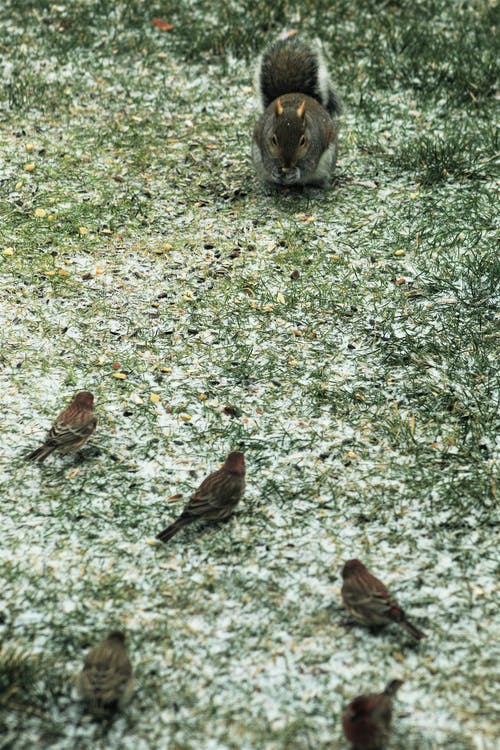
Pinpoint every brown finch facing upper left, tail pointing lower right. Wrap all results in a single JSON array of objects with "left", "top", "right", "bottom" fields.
[{"left": 342, "top": 560, "right": 425, "bottom": 640}]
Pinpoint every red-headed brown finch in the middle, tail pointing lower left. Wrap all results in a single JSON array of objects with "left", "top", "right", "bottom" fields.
[{"left": 156, "top": 451, "right": 245, "bottom": 542}]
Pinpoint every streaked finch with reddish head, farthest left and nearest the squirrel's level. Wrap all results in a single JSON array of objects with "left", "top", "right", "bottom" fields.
[{"left": 25, "top": 391, "right": 97, "bottom": 463}]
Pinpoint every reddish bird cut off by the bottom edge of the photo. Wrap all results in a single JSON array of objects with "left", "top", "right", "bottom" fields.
[{"left": 342, "top": 680, "right": 403, "bottom": 750}]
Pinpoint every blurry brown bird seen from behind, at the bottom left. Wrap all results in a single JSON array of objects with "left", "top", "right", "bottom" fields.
[{"left": 77, "top": 630, "right": 134, "bottom": 716}]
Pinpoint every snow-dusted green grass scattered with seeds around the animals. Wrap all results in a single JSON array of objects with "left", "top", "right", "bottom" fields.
[{"left": 0, "top": 0, "right": 499, "bottom": 750}]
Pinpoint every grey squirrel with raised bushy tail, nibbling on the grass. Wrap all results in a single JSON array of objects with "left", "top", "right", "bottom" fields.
[{"left": 252, "top": 38, "right": 341, "bottom": 187}]
